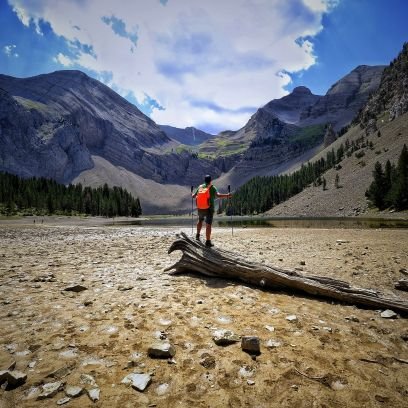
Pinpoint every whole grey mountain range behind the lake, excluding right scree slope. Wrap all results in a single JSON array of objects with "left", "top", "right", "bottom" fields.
[{"left": 0, "top": 61, "right": 388, "bottom": 213}]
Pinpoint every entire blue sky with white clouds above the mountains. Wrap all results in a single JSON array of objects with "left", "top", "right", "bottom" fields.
[{"left": 0, "top": 0, "right": 408, "bottom": 133}]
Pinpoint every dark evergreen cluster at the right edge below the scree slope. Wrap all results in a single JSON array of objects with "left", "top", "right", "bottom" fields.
[{"left": 365, "top": 144, "right": 408, "bottom": 211}]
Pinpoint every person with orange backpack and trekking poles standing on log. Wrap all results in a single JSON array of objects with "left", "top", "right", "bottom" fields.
[{"left": 192, "top": 174, "right": 232, "bottom": 247}]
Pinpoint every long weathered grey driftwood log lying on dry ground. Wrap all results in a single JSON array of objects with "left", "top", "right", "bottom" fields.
[{"left": 166, "top": 233, "right": 408, "bottom": 314}]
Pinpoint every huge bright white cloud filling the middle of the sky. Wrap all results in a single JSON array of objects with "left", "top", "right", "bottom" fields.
[{"left": 9, "top": 0, "right": 338, "bottom": 129}]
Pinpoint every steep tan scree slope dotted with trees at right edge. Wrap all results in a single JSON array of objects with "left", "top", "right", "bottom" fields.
[{"left": 267, "top": 43, "right": 408, "bottom": 217}]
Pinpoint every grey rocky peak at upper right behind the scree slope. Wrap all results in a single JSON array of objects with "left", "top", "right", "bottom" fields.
[{"left": 296, "top": 65, "right": 385, "bottom": 131}]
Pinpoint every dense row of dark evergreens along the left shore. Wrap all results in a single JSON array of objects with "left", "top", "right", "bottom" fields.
[{"left": 0, "top": 172, "right": 142, "bottom": 217}]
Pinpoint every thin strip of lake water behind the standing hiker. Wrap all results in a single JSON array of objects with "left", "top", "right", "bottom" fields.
[{"left": 107, "top": 216, "right": 408, "bottom": 229}]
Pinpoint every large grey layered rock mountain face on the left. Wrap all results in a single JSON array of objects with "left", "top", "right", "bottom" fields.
[{"left": 0, "top": 71, "right": 230, "bottom": 184}]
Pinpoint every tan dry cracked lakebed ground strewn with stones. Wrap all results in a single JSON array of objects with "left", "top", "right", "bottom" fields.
[{"left": 0, "top": 222, "right": 408, "bottom": 408}]
